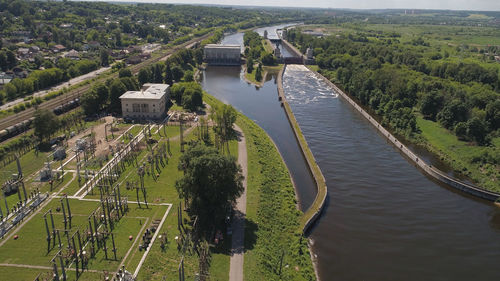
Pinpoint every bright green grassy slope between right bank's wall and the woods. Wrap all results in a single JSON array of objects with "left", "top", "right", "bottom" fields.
[{"left": 417, "top": 117, "right": 500, "bottom": 192}]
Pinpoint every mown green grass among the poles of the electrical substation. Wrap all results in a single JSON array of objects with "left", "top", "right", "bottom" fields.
[{"left": 0, "top": 112, "right": 237, "bottom": 280}]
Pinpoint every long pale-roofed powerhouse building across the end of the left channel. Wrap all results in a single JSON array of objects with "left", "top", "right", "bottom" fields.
[{"left": 203, "top": 44, "right": 241, "bottom": 65}]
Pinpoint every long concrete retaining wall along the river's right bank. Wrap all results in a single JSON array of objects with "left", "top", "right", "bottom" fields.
[{"left": 313, "top": 71, "right": 500, "bottom": 202}]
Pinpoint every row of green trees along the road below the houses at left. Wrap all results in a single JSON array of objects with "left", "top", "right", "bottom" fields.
[{"left": 0, "top": 59, "right": 99, "bottom": 103}]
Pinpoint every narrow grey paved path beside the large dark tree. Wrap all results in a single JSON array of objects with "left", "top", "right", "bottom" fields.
[{"left": 229, "top": 125, "right": 248, "bottom": 281}]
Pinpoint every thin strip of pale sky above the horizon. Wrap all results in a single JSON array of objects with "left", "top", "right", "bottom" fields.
[{"left": 97, "top": 0, "right": 500, "bottom": 11}]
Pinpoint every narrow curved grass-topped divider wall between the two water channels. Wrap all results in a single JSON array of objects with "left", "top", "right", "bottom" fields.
[{"left": 278, "top": 65, "right": 328, "bottom": 233}]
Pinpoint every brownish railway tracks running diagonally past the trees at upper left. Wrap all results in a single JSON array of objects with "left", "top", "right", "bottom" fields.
[{"left": 0, "top": 33, "right": 213, "bottom": 131}]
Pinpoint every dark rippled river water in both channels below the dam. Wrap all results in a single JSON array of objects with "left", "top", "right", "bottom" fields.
[{"left": 203, "top": 27, "right": 500, "bottom": 280}]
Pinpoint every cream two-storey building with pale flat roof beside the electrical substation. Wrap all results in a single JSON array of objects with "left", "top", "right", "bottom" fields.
[{"left": 120, "top": 83, "right": 170, "bottom": 119}]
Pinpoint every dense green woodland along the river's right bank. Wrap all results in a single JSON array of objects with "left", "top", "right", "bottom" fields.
[{"left": 287, "top": 29, "right": 500, "bottom": 145}]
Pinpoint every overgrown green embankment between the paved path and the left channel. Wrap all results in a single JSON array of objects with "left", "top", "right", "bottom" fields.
[{"left": 204, "top": 95, "right": 315, "bottom": 281}]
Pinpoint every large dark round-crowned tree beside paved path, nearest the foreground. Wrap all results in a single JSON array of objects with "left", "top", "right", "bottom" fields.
[{"left": 175, "top": 144, "right": 244, "bottom": 233}]
